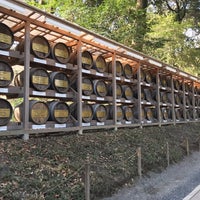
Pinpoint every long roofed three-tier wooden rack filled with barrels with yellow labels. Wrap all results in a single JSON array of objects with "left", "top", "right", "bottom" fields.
[{"left": 0, "top": 0, "right": 200, "bottom": 135}]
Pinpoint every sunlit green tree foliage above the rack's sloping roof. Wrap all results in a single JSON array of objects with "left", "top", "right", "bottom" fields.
[{"left": 26, "top": 0, "right": 200, "bottom": 75}]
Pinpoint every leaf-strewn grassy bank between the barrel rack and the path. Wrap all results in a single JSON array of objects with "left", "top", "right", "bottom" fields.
[{"left": 0, "top": 123, "right": 200, "bottom": 200}]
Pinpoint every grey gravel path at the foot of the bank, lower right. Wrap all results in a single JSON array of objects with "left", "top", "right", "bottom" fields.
[{"left": 104, "top": 152, "right": 200, "bottom": 200}]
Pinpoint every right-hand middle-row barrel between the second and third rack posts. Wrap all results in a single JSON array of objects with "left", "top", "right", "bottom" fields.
[{"left": 93, "top": 80, "right": 108, "bottom": 97}]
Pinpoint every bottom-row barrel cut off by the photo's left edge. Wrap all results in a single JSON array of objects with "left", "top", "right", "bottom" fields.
[{"left": 0, "top": 98, "right": 13, "bottom": 126}]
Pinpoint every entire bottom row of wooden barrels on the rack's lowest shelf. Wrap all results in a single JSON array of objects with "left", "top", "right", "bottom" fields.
[{"left": 0, "top": 99, "right": 200, "bottom": 126}]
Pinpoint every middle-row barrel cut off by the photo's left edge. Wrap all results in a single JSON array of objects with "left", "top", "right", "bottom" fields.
[{"left": 0, "top": 61, "right": 14, "bottom": 87}]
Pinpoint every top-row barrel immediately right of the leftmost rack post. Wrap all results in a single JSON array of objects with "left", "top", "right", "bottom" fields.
[{"left": 30, "top": 35, "right": 51, "bottom": 59}]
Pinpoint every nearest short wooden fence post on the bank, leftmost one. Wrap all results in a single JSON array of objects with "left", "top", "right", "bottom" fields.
[{"left": 85, "top": 156, "right": 90, "bottom": 200}]
